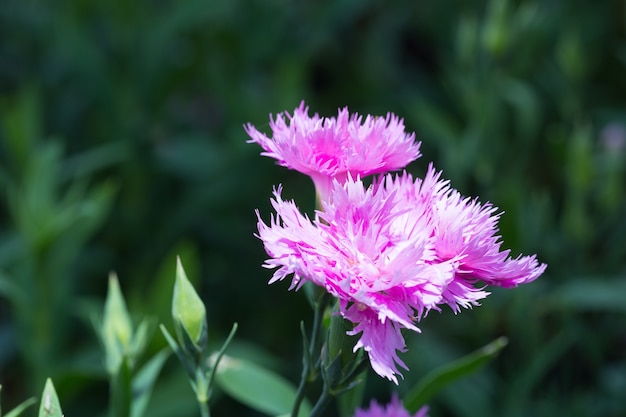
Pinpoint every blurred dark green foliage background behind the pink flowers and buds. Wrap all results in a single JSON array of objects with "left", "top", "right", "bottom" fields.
[{"left": 0, "top": 0, "right": 626, "bottom": 417}]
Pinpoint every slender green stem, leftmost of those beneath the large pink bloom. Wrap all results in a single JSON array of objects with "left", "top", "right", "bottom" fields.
[{"left": 291, "top": 293, "right": 332, "bottom": 417}]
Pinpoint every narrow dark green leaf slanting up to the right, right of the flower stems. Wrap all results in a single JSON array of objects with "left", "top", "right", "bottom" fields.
[{"left": 404, "top": 337, "right": 508, "bottom": 413}]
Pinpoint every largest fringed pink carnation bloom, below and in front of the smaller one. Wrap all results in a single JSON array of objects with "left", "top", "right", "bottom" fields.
[{"left": 257, "top": 165, "right": 546, "bottom": 383}]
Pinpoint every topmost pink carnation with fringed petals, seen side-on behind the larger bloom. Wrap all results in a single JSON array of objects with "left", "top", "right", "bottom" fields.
[{"left": 244, "top": 101, "right": 420, "bottom": 199}]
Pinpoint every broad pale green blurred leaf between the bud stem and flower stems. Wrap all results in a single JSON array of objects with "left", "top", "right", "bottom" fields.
[{"left": 215, "top": 356, "right": 311, "bottom": 417}]
